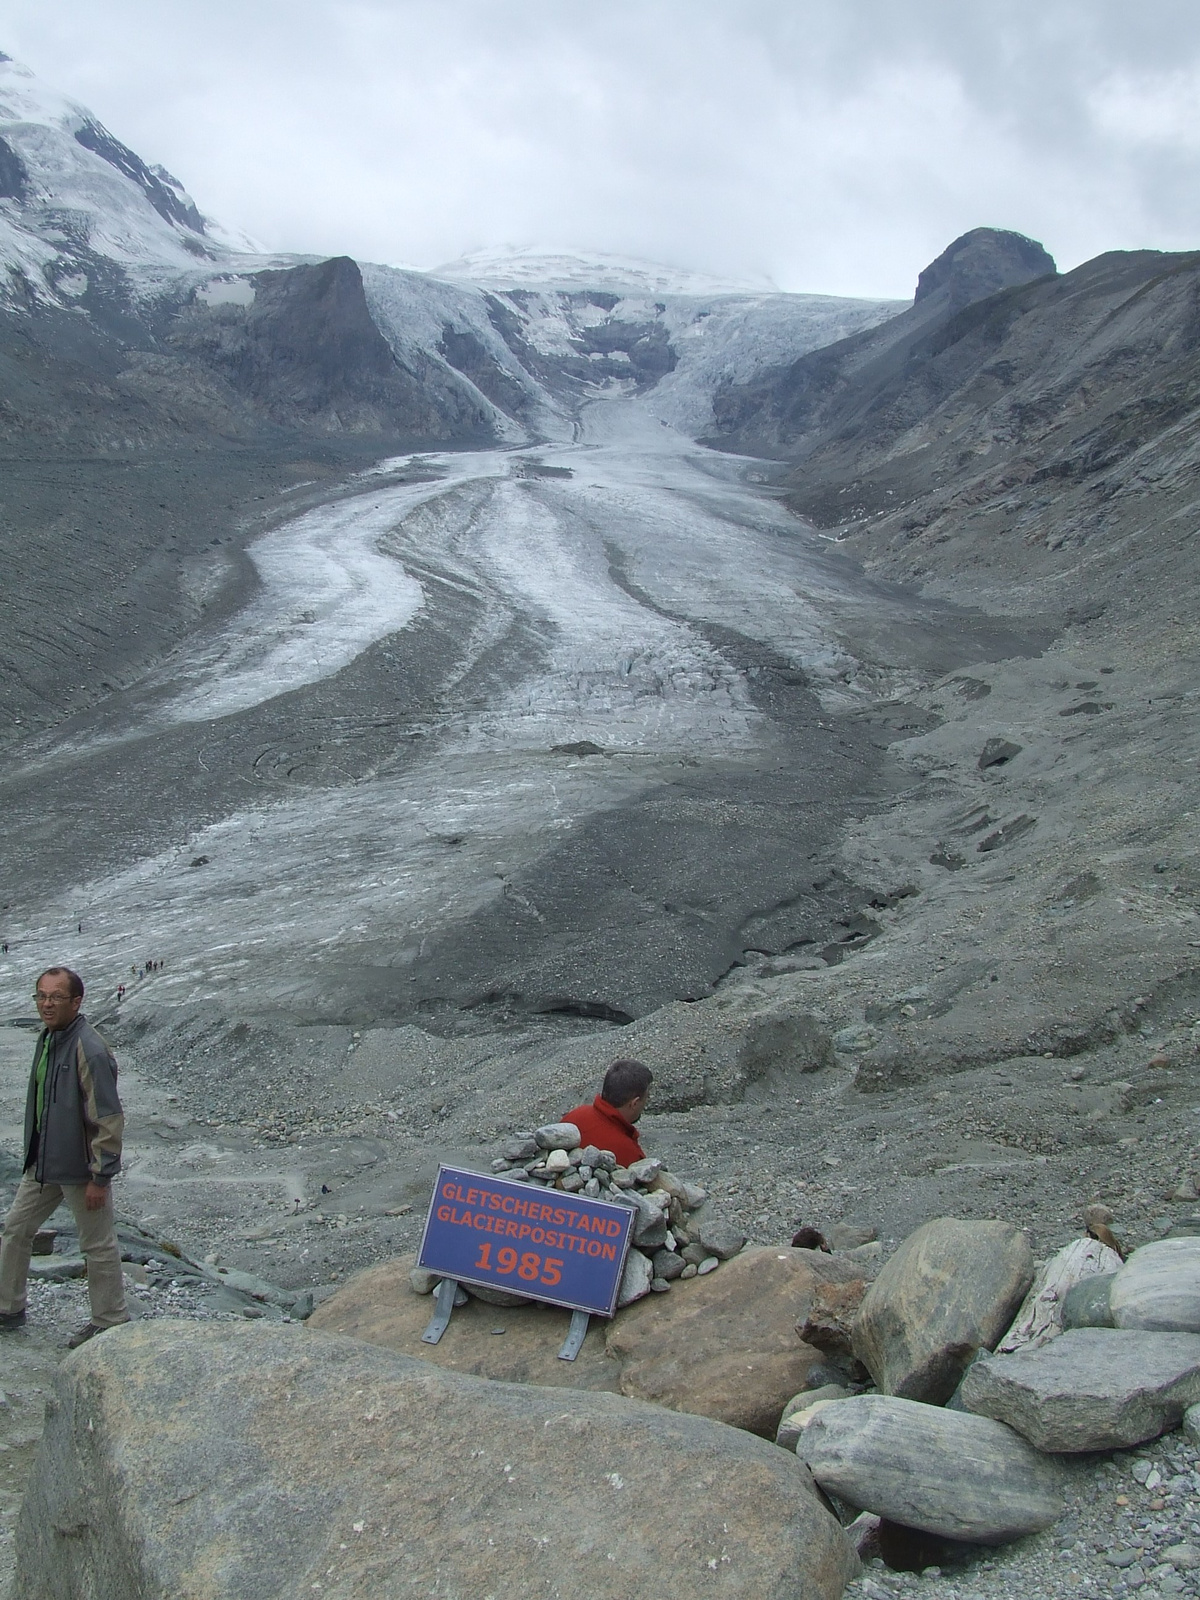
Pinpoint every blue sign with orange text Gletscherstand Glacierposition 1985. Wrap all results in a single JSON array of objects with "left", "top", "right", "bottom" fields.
[{"left": 416, "top": 1166, "right": 635, "bottom": 1317}]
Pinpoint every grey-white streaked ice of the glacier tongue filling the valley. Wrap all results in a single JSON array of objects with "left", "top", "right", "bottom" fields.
[{"left": 0, "top": 402, "right": 883, "bottom": 1013}]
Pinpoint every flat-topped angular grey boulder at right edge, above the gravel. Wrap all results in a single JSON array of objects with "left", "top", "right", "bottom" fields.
[{"left": 960, "top": 1328, "right": 1200, "bottom": 1451}]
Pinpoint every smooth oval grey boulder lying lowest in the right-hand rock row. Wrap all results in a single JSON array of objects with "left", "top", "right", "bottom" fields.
[{"left": 795, "top": 1395, "right": 1062, "bottom": 1544}]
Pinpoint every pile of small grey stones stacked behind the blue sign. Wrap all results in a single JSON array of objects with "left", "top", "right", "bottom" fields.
[{"left": 491, "top": 1122, "right": 746, "bottom": 1306}]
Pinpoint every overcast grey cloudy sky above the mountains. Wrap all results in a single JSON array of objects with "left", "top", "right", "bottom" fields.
[{"left": 0, "top": 0, "right": 1200, "bottom": 296}]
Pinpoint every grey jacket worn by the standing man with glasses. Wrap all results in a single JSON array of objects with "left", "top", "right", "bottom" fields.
[{"left": 24, "top": 1013, "right": 125, "bottom": 1184}]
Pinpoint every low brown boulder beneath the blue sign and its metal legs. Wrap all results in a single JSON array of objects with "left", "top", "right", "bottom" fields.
[{"left": 306, "top": 1256, "right": 621, "bottom": 1394}]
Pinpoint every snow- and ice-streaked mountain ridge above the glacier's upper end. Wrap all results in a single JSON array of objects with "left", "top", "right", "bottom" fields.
[{"left": 0, "top": 58, "right": 894, "bottom": 445}]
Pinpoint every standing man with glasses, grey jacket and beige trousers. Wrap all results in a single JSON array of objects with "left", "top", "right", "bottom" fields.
[{"left": 0, "top": 966, "right": 130, "bottom": 1350}]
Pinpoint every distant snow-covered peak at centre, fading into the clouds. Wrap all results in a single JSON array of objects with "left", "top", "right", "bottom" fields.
[{"left": 430, "top": 245, "right": 774, "bottom": 296}]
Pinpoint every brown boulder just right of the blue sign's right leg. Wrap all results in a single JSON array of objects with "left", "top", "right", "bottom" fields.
[{"left": 606, "top": 1246, "right": 861, "bottom": 1438}]
